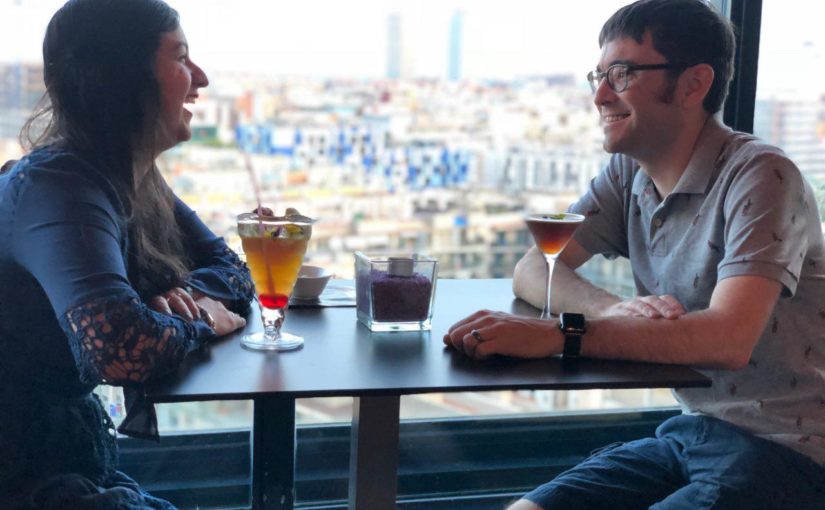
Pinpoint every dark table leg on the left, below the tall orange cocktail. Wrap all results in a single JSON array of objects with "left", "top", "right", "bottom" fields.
[{"left": 252, "top": 396, "right": 295, "bottom": 510}]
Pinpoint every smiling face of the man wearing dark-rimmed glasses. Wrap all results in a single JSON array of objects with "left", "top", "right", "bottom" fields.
[{"left": 593, "top": 33, "right": 681, "bottom": 161}]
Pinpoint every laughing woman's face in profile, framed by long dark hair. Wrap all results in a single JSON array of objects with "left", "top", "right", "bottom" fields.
[{"left": 154, "top": 28, "right": 209, "bottom": 155}]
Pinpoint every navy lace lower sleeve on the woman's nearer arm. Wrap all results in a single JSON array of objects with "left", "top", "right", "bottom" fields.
[{"left": 61, "top": 294, "right": 214, "bottom": 385}]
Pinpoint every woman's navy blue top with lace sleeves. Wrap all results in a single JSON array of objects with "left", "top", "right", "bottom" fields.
[{"left": 0, "top": 147, "right": 254, "bottom": 493}]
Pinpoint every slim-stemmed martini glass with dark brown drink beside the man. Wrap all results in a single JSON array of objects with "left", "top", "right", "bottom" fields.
[{"left": 526, "top": 213, "right": 584, "bottom": 319}]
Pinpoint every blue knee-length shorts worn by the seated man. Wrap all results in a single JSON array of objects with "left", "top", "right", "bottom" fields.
[{"left": 524, "top": 415, "right": 825, "bottom": 510}]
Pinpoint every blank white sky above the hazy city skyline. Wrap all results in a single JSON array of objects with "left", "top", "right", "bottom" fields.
[{"left": 0, "top": 0, "right": 825, "bottom": 91}]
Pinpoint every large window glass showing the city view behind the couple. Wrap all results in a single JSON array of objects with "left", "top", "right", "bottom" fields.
[{"left": 9, "top": 0, "right": 784, "bottom": 506}]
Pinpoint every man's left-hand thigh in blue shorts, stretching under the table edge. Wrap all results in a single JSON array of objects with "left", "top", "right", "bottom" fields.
[{"left": 510, "top": 438, "right": 687, "bottom": 510}]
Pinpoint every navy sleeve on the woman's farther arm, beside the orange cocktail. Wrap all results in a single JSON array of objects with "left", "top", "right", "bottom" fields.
[{"left": 175, "top": 197, "right": 255, "bottom": 315}]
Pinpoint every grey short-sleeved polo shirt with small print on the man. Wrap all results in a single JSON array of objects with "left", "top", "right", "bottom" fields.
[{"left": 571, "top": 113, "right": 825, "bottom": 464}]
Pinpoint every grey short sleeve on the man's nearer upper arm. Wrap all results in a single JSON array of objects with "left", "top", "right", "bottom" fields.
[{"left": 718, "top": 146, "right": 808, "bottom": 296}]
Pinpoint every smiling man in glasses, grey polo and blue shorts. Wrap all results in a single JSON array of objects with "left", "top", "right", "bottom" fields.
[{"left": 444, "top": 0, "right": 825, "bottom": 510}]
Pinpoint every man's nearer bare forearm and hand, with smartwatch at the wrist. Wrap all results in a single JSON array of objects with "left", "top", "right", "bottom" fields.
[{"left": 444, "top": 276, "right": 782, "bottom": 370}]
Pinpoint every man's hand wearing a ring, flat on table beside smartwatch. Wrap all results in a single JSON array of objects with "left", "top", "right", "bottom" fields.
[{"left": 444, "top": 310, "right": 564, "bottom": 359}]
